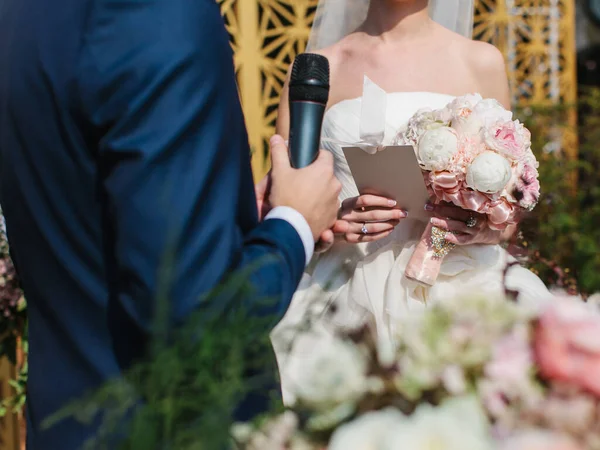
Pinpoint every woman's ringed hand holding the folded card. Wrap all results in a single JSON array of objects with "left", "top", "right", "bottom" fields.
[{"left": 338, "top": 195, "right": 407, "bottom": 244}]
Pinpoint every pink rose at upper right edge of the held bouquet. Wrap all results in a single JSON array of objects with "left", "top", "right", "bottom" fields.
[{"left": 483, "top": 120, "right": 531, "bottom": 161}]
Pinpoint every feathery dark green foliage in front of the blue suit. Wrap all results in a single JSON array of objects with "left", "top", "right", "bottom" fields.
[{"left": 45, "top": 266, "right": 282, "bottom": 450}]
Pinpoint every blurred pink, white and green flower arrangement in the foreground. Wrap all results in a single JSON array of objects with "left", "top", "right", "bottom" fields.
[{"left": 233, "top": 297, "right": 600, "bottom": 450}]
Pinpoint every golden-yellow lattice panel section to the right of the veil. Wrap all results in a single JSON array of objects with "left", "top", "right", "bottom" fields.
[{"left": 474, "top": 0, "right": 577, "bottom": 157}]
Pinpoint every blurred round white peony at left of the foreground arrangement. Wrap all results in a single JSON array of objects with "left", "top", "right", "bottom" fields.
[{"left": 285, "top": 329, "right": 369, "bottom": 411}]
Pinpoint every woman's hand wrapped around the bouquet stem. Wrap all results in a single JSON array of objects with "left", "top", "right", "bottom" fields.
[{"left": 425, "top": 204, "right": 503, "bottom": 245}]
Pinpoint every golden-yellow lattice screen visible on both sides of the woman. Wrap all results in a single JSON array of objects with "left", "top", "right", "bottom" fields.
[{"left": 218, "top": 0, "right": 576, "bottom": 178}]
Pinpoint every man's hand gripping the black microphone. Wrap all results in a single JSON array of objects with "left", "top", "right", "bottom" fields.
[{"left": 268, "top": 136, "right": 342, "bottom": 242}]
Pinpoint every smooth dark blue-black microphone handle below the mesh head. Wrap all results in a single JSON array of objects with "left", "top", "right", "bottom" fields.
[{"left": 290, "top": 101, "right": 326, "bottom": 169}]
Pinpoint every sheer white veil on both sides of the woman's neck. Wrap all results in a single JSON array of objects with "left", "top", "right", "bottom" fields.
[{"left": 306, "top": 0, "right": 474, "bottom": 52}]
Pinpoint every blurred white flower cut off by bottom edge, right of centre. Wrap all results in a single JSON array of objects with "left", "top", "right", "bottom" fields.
[{"left": 377, "top": 397, "right": 494, "bottom": 450}]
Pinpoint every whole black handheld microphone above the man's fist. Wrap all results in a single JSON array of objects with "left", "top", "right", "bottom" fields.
[{"left": 289, "top": 53, "right": 329, "bottom": 169}]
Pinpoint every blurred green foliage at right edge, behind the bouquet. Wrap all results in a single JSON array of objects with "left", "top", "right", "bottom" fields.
[{"left": 520, "top": 89, "right": 600, "bottom": 295}]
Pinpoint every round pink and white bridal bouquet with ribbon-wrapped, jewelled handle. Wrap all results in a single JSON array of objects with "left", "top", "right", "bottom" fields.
[{"left": 397, "top": 94, "right": 540, "bottom": 285}]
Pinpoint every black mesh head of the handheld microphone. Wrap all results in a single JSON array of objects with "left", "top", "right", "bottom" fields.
[{"left": 290, "top": 53, "right": 329, "bottom": 105}]
